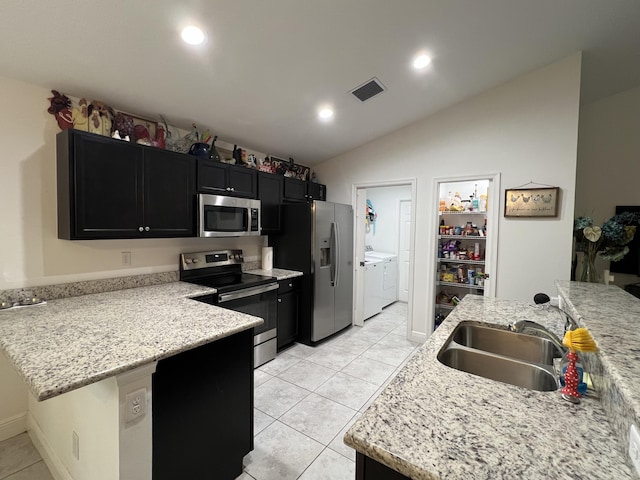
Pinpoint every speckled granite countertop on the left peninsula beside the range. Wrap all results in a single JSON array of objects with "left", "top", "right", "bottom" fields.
[{"left": 0, "top": 282, "right": 263, "bottom": 400}]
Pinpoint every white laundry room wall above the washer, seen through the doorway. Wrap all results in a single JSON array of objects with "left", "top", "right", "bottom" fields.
[{"left": 365, "top": 185, "right": 411, "bottom": 254}]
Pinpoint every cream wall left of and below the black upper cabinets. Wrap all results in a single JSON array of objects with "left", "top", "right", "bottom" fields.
[{"left": 0, "top": 73, "right": 262, "bottom": 439}]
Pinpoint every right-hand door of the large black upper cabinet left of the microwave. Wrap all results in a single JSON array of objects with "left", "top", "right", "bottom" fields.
[{"left": 143, "top": 148, "right": 196, "bottom": 237}]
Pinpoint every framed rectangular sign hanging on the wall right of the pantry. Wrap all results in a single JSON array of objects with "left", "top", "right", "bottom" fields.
[{"left": 504, "top": 187, "right": 560, "bottom": 217}]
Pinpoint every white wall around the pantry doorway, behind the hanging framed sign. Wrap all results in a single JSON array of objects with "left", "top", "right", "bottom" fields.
[{"left": 316, "top": 54, "right": 581, "bottom": 335}]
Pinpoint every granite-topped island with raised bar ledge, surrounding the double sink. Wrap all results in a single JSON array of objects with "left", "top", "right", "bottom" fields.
[{"left": 344, "top": 282, "right": 640, "bottom": 480}]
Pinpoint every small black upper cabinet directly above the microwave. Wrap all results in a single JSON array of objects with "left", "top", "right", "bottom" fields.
[{"left": 198, "top": 158, "right": 258, "bottom": 198}]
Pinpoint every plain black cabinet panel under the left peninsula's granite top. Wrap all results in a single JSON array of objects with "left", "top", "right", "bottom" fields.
[{"left": 152, "top": 329, "right": 253, "bottom": 480}]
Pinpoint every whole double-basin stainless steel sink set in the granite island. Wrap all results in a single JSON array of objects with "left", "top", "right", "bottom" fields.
[{"left": 437, "top": 322, "right": 562, "bottom": 392}]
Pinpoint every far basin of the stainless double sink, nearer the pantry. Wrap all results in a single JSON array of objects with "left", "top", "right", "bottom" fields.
[{"left": 452, "top": 322, "right": 562, "bottom": 365}]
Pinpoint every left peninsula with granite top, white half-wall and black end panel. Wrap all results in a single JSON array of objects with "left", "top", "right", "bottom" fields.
[{"left": 0, "top": 282, "right": 262, "bottom": 480}]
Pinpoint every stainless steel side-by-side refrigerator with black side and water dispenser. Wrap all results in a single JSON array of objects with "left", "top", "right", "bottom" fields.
[{"left": 269, "top": 201, "right": 353, "bottom": 345}]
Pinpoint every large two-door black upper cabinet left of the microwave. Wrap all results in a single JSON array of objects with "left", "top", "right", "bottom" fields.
[{"left": 57, "top": 130, "right": 196, "bottom": 240}]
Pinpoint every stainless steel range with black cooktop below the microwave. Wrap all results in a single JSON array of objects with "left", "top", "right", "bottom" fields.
[{"left": 180, "top": 250, "right": 278, "bottom": 367}]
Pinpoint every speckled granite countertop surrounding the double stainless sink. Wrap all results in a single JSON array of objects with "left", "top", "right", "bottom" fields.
[{"left": 344, "top": 291, "right": 640, "bottom": 480}]
